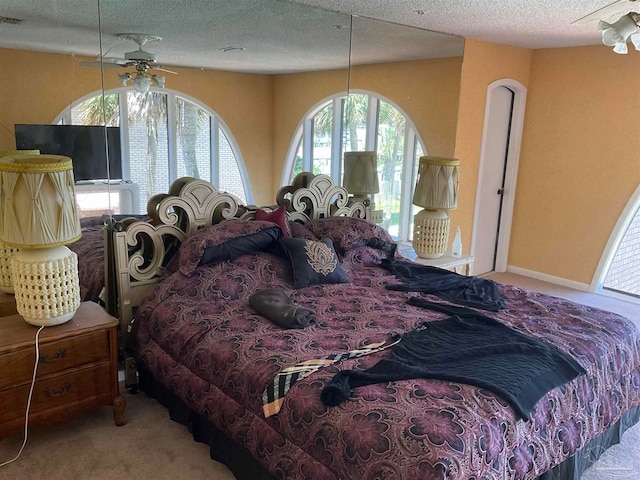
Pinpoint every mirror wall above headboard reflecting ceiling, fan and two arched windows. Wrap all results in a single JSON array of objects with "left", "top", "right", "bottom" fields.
[{"left": 0, "top": 0, "right": 462, "bottom": 237}]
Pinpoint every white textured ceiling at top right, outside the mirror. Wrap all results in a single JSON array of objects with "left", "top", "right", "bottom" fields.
[{"left": 294, "top": 0, "right": 640, "bottom": 48}]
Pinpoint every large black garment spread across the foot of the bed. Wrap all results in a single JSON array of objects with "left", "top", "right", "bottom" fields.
[{"left": 321, "top": 302, "right": 585, "bottom": 419}]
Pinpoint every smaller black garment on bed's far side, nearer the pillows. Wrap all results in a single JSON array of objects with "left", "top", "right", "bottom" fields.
[{"left": 380, "top": 259, "right": 505, "bottom": 312}]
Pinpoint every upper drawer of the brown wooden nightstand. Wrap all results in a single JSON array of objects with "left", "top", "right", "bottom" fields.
[{"left": 0, "top": 330, "right": 110, "bottom": 390}]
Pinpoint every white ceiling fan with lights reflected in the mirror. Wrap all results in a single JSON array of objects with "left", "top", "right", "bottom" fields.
[{"left": 80, "top": 33, "right": 177, "bottom": 93}]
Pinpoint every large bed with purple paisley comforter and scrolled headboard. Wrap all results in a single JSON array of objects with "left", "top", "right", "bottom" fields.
[{"left": 113, "top": 174, "right": 640, "bottom": 480}]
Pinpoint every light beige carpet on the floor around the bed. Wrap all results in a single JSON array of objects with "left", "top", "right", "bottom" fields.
[{"left": 0, "top": 273, "right": 640, "bottom": 480}]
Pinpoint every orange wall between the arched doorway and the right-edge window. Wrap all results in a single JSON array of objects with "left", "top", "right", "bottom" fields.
[{"left": 508, "top": 46, "right": 640, "bottom": 284}]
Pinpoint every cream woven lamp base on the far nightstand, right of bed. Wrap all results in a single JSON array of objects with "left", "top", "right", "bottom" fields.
[{"left": 413, "top": 209, "right": 451, "bottom": 258}]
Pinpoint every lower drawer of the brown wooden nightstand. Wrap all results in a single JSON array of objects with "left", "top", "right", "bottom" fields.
[{"left": 0, "top": 363, "right": 113, "bottom": 424}]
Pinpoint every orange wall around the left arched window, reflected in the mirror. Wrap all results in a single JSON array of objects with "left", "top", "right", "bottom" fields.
[{"left": 0, "top": 49, "right": 273, "bottom": 204}]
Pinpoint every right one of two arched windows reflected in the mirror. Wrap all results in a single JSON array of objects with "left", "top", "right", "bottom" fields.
[{"left": 282, "top": 90, "right": 427, "bottom": 240}]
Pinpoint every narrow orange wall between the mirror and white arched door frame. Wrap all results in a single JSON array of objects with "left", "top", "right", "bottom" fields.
[{"left": 450, "top": 39, "right": 532, "bottom": 255}]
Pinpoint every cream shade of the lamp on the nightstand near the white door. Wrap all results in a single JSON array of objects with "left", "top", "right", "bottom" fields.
[{"left": 413, "top": 156, "right": 460, "bottom": 210}]
